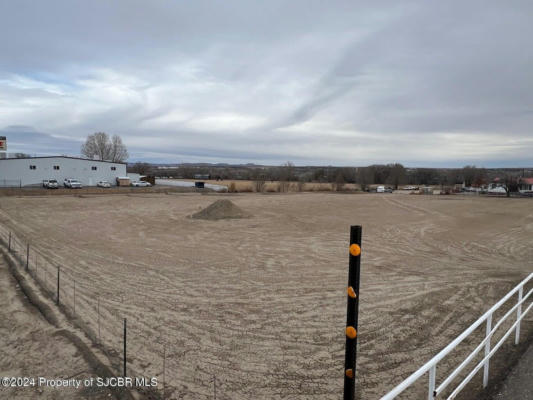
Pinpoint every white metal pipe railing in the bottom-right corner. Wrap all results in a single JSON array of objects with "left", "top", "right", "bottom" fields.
[{"left": 381, "top": 273, "right": 533, "bottom": 400}]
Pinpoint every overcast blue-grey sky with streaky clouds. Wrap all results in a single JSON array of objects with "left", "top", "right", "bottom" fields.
[{"left": 0, "top": 0, "right": 533, "bottom": 167}]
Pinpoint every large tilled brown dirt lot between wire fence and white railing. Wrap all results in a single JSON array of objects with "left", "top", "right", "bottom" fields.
[{"left": 0, "top": 193, "right": 533, "bottom": 400}]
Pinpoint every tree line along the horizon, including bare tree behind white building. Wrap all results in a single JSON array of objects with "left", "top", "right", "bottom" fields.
[{"left": 75, "top": 132, "right": 524, "bottom": 191}]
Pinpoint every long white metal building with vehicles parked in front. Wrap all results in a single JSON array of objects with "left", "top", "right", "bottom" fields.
[{"left": 0, "top": 156, "right": 126, "bottom": 186}]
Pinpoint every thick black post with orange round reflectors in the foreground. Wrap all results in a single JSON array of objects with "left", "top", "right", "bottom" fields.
[{"left": 344, "top": 225, "right": 362, "bottom": 400}]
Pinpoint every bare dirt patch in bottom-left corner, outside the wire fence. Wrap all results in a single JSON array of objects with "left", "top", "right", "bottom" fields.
[{"left": 0, "top": 256, "right": 111, "bottom": 400}]
